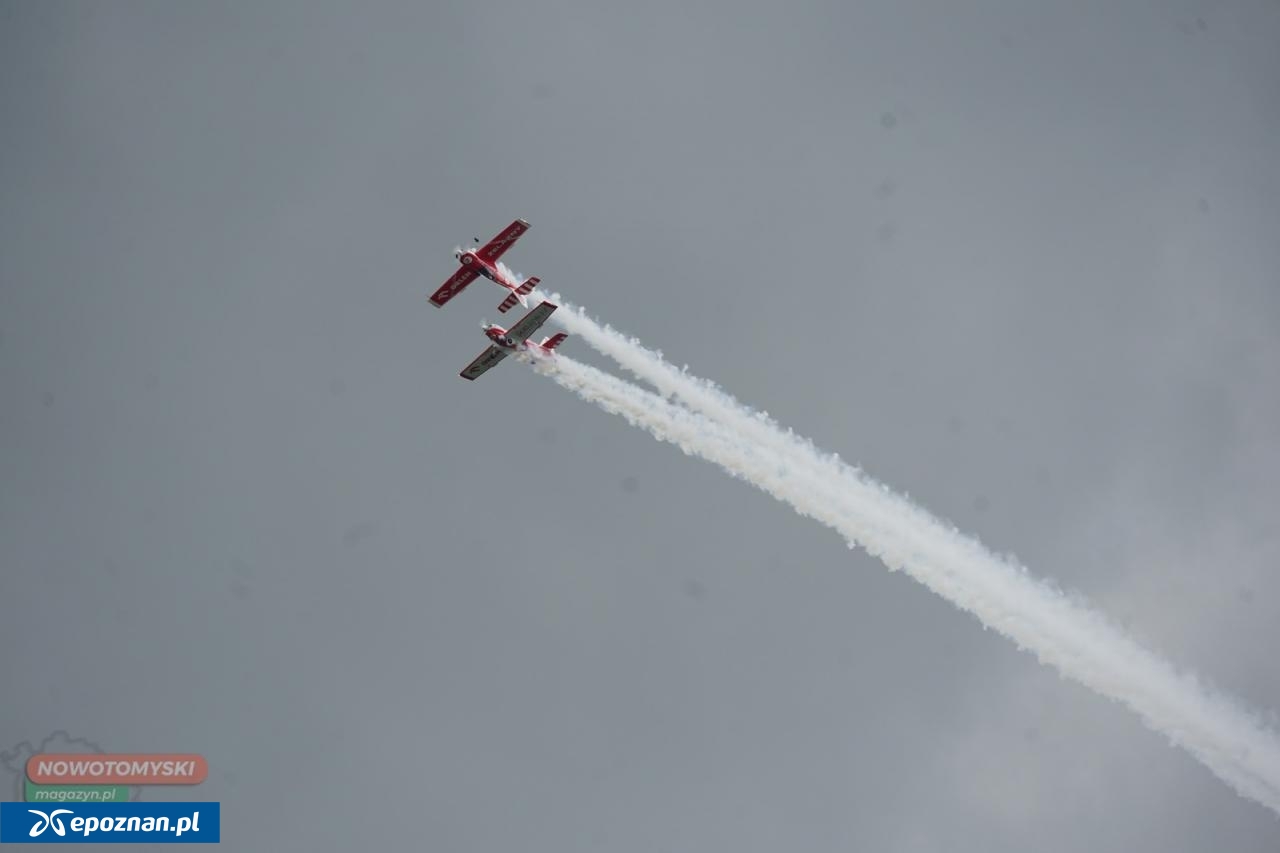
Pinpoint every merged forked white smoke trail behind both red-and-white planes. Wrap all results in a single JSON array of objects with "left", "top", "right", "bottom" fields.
[{"left": 522, "top": 335, "right": 1280, "bottom": 815}]
